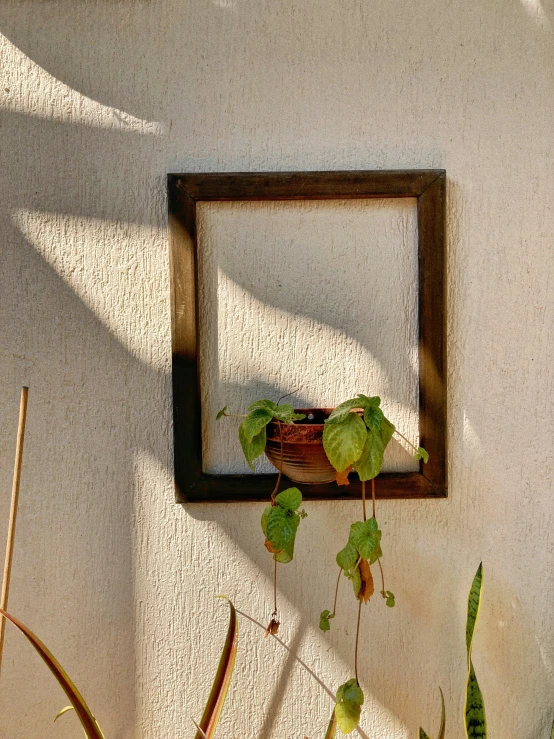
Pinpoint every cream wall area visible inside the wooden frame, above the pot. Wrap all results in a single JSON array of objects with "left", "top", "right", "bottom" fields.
[{"left": 197, "top": 198, "right": 419, "bottom": 475}]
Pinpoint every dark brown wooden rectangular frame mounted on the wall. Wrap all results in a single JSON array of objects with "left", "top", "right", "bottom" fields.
[{"left": 168, "top": 169, "right": 447, "bottom": 503}]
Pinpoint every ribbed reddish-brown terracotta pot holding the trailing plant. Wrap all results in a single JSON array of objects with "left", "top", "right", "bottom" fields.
[{"left": 265, "top": 408, "right": 336, "bottom": 484}]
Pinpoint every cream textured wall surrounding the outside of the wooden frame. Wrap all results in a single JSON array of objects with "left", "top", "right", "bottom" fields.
[{"left": 0, "top": 0, "right": 554, "bottom": 739}]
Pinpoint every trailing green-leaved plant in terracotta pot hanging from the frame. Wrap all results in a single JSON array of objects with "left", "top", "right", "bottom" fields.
[{"left": 217, "top": 394, "right": 428, "bottom": 660}]
